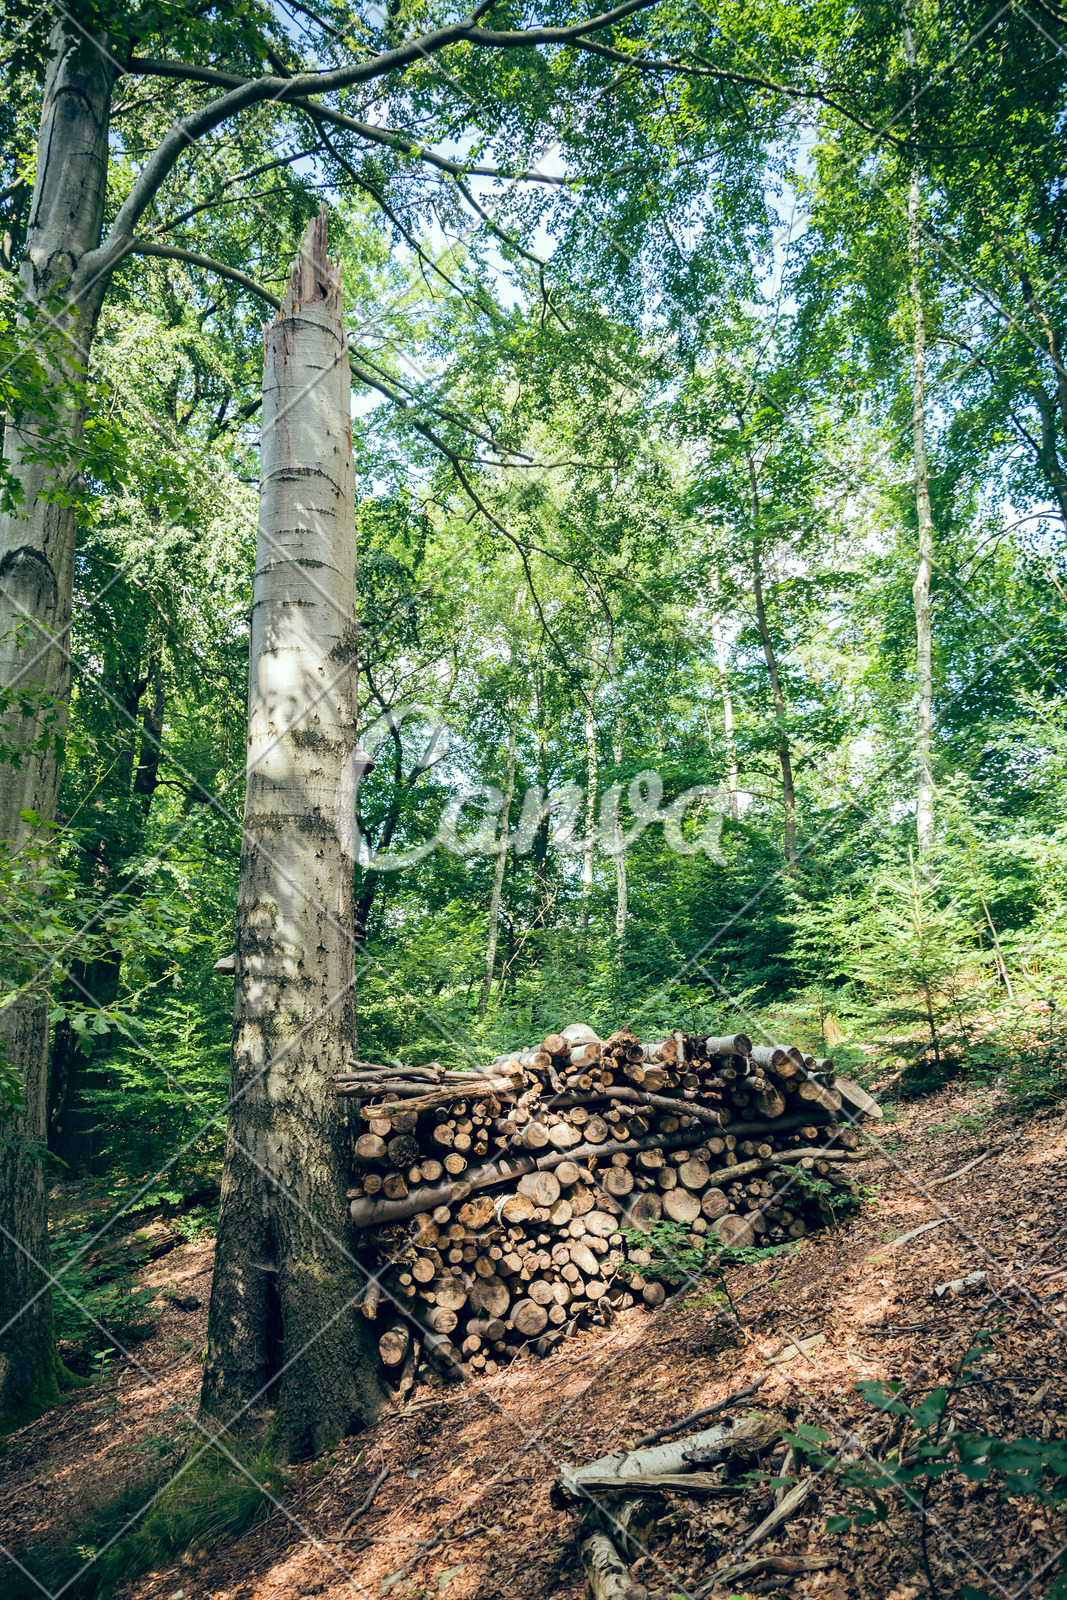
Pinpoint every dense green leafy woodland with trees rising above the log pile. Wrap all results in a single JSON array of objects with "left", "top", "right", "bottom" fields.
[{"left": 0, "top": 0, "right": 1067, "bottom": 1600}]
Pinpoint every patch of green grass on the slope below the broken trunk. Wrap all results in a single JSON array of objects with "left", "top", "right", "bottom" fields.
[{"left": 5, "top": 1446, "right": 283, "bottom": 1600}]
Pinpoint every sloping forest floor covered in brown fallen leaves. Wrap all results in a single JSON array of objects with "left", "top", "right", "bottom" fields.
[{"left": 0, "top": 1086, "right": 1067, "bottom": 1600}]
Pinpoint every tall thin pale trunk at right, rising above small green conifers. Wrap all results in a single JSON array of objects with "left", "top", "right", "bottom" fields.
[{"left": 904, "top": 21, "right": 934, "bottom": 867}]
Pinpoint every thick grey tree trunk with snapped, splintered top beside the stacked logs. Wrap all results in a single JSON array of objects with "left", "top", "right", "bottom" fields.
[{"left": 200, "top": 216, "right": 386, "bottom": 1458}]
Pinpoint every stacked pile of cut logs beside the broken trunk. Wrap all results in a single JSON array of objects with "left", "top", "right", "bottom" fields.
[{"left": 336, "top": 1024, "right": 880, "bottom": 1392}]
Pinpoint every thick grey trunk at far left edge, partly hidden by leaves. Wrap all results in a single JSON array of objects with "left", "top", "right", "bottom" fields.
[{"left": 0, "top": 18, "right": 112, "bottom": 1427}]
